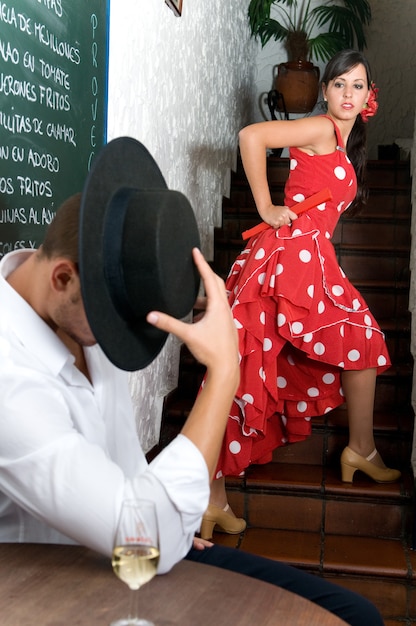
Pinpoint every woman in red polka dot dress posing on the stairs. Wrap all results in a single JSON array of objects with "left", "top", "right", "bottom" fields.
[{"left": 201, "top": 50, "right": 400, "bottom": 538}]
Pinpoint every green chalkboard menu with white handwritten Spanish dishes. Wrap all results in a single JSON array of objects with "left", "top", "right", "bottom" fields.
[{"left": 0, "top": 0, "right": 109, "bottom": 258}]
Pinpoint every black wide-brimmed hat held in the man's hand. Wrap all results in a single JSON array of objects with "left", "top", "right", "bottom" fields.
[{"left": 79, "top": 137, "right": 200, "bottom": 371}]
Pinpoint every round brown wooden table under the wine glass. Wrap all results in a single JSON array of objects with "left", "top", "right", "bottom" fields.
[{"left": 0, "top": 544, "right": 345, "bottom": 626}]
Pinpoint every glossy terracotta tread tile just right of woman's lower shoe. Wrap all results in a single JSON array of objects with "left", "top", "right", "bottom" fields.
[{"left": 240, "top": 528, "right": 321, "bottom": 569}]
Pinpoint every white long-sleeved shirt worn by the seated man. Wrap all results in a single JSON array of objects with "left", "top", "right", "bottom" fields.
[{"left": 0, "top": 250, "right": 209, "bottom": 573}]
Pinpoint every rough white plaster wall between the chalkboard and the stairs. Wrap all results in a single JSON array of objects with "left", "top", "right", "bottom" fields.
[{"left": 108, "top": 0, "right": 254, "bottom": 449}]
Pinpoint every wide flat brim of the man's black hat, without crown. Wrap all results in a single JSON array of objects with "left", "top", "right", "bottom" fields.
[{"left": 79, "top": 137, "right": 200, "bottom": 371}]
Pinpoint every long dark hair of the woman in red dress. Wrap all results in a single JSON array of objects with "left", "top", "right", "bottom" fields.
[{"left": 322, "top": 50, "right": 371, "bottom": 214}]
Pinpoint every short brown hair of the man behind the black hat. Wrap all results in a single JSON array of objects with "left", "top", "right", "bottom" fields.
[{"left": 41, "top": 193, "right": 81, "bottom": 264}]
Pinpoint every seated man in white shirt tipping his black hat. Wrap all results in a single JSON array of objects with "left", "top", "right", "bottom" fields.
[{"left": 0, "top": 141, "right": 383, "bottom": 626}]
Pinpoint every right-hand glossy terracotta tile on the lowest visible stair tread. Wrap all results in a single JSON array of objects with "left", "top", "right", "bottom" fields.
[{"left": 324, "top": 535, "right": 408, "bottom": 578}]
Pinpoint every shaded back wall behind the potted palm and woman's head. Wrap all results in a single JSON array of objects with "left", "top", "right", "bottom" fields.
[{"left": 249, "top": 0, "right": 416, "bottom": 159}]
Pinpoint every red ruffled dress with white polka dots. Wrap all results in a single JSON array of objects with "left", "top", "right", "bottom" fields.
[{"left": 217, "top": 117, "right": 390, "bottom": 478}]
